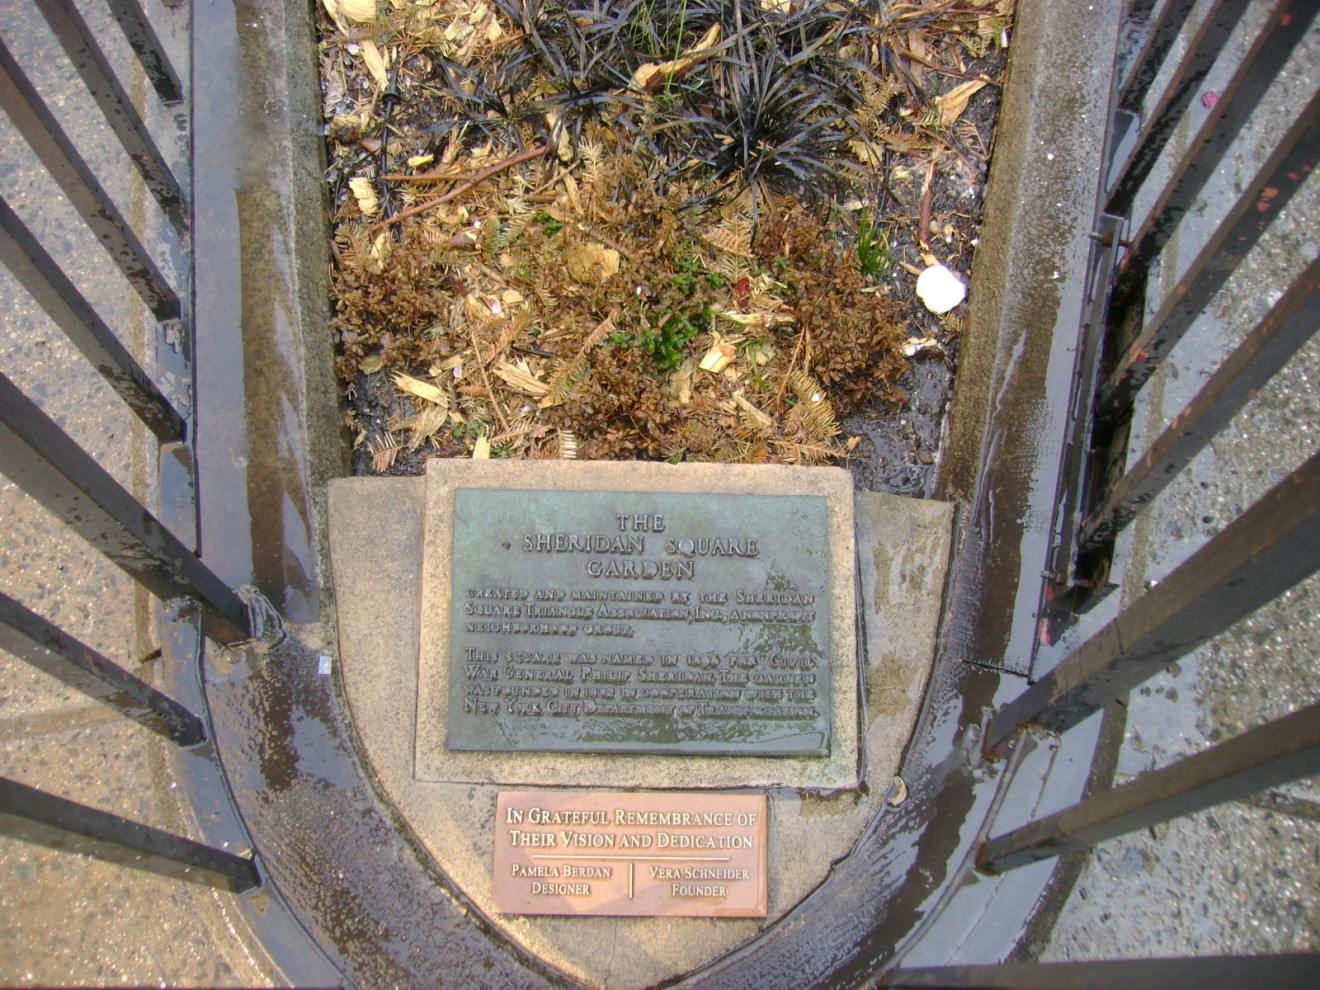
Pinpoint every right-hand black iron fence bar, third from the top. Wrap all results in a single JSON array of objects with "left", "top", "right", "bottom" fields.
[{"left": 1113, "top": 0, "right": 1320, "bottom": 312}]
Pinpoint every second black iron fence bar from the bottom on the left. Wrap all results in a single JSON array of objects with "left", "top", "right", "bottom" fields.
[{"left": 0, "top": 593, "right": 206, "bottom": 746}]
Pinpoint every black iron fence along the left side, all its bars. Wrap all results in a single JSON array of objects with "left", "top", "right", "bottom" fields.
[{"left": 0, "top": 0, "right": 261, "bottom": 891}]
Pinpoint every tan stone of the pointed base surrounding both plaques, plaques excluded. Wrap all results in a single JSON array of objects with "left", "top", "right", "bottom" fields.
[{"left": 327, "top": 472, "right": 953, "bottom": 990}]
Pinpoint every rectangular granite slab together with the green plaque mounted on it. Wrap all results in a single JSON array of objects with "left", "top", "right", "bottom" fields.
[{"left": 416, "top": 461, "right": 861, "bottom": 788}]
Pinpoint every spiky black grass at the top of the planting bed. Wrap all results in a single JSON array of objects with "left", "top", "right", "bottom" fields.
[{"left": 442, "top": 0, "right": 875, "bottom": 214}]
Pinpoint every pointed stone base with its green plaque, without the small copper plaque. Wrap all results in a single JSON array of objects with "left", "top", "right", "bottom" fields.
[{"left": 330, "top": 461, "right": 953, "bottom": 990}]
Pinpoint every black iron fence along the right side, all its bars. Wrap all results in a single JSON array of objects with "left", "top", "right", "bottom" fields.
[{"left": 880, "top": 0, "right": 1320, "bottom": 987}]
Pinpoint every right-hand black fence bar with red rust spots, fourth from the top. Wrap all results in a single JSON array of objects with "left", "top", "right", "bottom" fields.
[{"left": 1096, "top": 85, "right": 1320, "bottom": 418}]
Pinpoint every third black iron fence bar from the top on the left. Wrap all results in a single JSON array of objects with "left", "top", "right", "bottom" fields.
[{"left": 0, "top": 40, "right": 181, "bottom": 319}]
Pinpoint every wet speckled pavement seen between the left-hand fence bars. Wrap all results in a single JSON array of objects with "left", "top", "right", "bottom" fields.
[{"left": 0, "top": 0, "right": 279, "bottom": 986}]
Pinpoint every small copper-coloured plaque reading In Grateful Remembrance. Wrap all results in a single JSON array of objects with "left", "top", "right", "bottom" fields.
[{"left": 494, "top": 791, "right": 767, "bottom": 917}]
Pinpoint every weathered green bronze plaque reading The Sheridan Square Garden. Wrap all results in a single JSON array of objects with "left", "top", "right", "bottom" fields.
[{"left": 447, "top": 488, "right": 830, "bottom": 756}]
